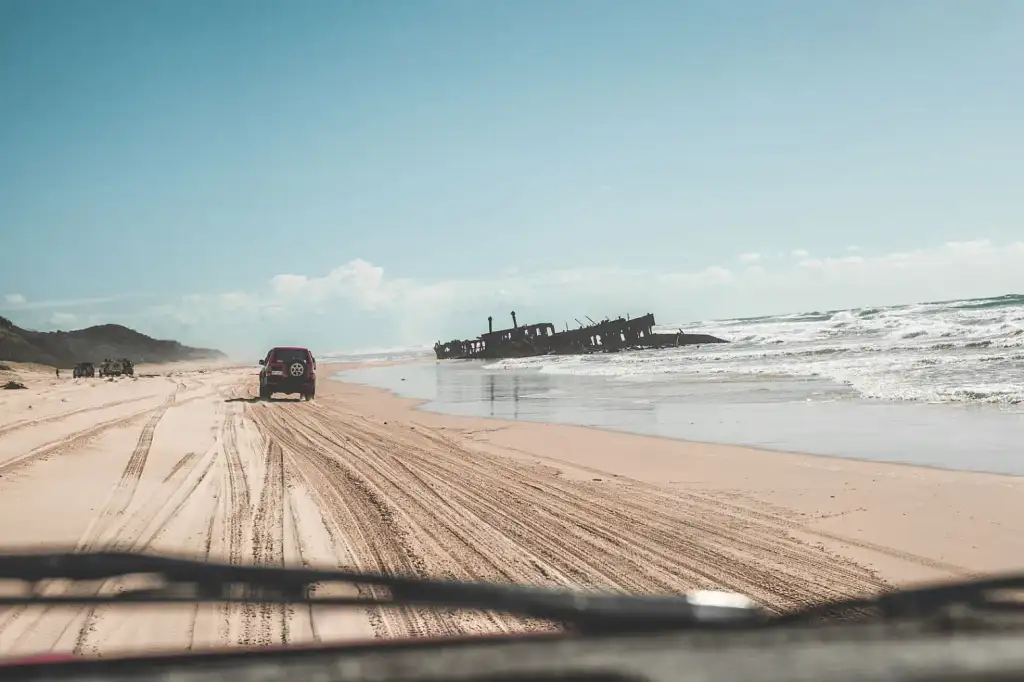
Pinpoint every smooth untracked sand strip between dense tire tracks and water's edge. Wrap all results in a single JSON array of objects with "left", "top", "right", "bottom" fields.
[{"left": 332, "top": 366, "right": 1024, "bottom": 584}]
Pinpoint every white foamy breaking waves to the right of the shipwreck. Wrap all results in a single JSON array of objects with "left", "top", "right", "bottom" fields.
[{"left": 486, "top": 294, "right": 1024, "bottom": 410}]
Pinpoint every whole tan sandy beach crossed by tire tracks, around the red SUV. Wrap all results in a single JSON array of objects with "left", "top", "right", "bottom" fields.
[{"left": 0, "top": 366, "right": 1024, "bottom": 655}]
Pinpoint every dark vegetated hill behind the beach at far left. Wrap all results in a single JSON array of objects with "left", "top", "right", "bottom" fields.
[{"left": 0, "top": 317, "right": 227, "bottom": 368}]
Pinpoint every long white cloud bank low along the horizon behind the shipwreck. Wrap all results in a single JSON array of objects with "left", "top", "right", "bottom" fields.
[{"left": 9, "top": 240, "right": 1024, "bottom": 350}]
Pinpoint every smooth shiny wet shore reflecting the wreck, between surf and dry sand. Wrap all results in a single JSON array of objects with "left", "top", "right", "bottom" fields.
[{"left": 339, "top": 360, "right": 1024, "bottom": 476}]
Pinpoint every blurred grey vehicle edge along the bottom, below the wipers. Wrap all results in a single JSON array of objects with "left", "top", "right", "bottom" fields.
[{"left": 6, "top": 623, "right": 1024, "bottom": 682}]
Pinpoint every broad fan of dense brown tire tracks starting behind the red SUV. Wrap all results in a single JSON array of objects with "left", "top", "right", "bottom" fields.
[{"left": 247, "top": 401, "right": 887, "bottom": 632}]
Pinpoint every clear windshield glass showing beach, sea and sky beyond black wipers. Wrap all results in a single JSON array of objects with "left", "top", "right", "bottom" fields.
[{"left": 0, "top": 0, "right": 1024, "bottom": 656}]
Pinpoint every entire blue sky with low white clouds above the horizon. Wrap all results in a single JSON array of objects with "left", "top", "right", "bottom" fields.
[{"left": 0, "top": 0, "right": 1024, "bottom": 355}]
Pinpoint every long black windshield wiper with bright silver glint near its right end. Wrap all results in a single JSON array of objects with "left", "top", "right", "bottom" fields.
[{"left": 0, "top": 552, "right": 766, "bottom": 633}]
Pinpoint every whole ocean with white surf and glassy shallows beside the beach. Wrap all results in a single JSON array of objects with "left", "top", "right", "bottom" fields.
[{"left": 333, "top": 295, "right": 1024, "bottom": 474}]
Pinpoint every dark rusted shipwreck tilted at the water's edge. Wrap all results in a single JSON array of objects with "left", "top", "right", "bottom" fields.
[{"left": 434, "top": 311, "right": 727, "bottom": 359}]
